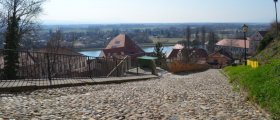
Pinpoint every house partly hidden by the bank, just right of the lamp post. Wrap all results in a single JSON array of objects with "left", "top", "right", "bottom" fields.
[{"left": 250, "top": 31, "right": 268, "bottom": 54}]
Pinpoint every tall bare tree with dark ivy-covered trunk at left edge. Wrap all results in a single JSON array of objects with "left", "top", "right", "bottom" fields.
[{"left": 0, "top": 0, "right": 45, "bottom": 79}]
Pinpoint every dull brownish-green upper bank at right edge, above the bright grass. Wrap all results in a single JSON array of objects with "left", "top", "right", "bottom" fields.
[{"left": 254, "top": 38, "right": 280, "bottom": 64}]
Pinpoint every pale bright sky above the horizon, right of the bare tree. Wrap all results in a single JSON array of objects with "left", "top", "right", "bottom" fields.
[{"left": 40, "top": 0, "right": 280, "bottom": 24}]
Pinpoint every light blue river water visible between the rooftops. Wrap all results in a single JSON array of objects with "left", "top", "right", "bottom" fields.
[{"left": 79, "top": 46, "right": 173, "bottom": 57}]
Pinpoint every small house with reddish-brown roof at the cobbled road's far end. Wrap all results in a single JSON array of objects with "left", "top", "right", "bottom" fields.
[{"left": 207, "top": 49, "right": 234, "bottom": 68}]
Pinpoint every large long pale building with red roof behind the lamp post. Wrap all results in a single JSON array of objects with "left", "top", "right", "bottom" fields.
[{"left": 215, "top": 38, "right": 250, "bottom": 57}]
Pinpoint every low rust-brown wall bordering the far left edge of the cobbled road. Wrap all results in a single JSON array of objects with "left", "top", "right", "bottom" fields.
[{"left": 167, "top": 61, "right": 209, "bottom": 73}]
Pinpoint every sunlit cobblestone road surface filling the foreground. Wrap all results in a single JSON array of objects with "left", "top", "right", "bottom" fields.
[{"left": 0, "top": 69, "right": 266, "bottom": 120}]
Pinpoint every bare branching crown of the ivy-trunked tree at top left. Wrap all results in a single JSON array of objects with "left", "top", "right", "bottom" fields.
[{"left": 0, "top": 0, "right": 46, "bottom": 35}]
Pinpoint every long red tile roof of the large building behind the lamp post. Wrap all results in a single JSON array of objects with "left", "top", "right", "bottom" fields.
[{"left": 216, "top": 38, "right": 250, "bottom": 48}]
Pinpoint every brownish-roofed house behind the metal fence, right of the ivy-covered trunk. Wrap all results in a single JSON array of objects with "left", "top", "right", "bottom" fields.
[{"left": 35, "top": 48, "right": 88, "bottom": 76}]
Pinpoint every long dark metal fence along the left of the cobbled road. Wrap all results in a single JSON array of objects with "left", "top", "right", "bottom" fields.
[{"left": 0, "top": 49, "right": 149, "bottom": 87}]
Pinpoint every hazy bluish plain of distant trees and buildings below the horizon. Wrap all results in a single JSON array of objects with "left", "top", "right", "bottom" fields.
[{"left": 0, "top": 23, "right": 269, "bottom": 51}]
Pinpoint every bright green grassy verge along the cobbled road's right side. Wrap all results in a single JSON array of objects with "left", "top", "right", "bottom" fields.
[{"left": 224, "top": 60, "right": 280, "bottom": 120}]
